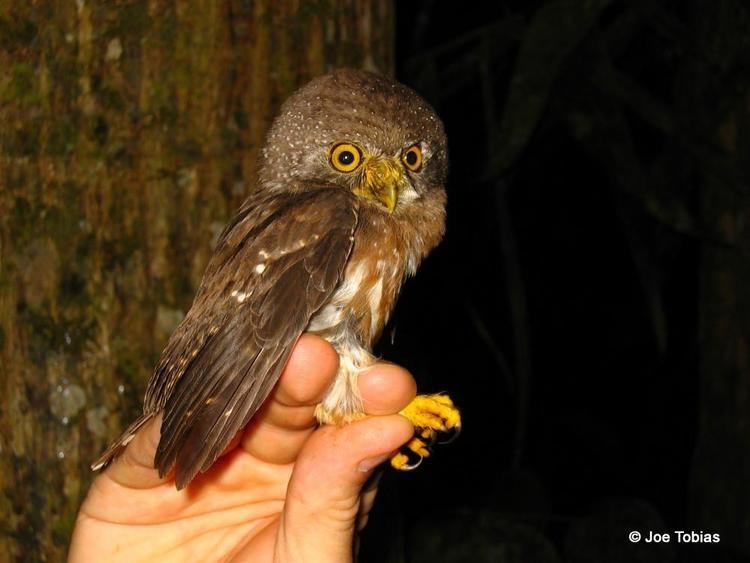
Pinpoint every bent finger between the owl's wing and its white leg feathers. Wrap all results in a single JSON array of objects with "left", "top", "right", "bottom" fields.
[{"left": 242, "top": 334, "right": 338, "bottom": 464}]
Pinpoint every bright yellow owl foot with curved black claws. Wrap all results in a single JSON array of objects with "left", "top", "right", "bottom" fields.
[{"left": 391, "top": 395, "right": 461, "bottom": 471}]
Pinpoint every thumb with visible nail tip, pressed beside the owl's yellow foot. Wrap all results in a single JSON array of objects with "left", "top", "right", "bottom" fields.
[{"left": 276, "top": 415, "right": 414, "bottom": 562}]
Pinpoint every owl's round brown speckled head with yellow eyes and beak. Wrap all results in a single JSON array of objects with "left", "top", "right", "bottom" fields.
[{"left": 260, "top": 69, "right": 448, "bottom": 214}]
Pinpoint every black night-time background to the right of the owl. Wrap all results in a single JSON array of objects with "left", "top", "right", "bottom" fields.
[{"left": 362, "top": 1, "right": 750, "bottom": 563}]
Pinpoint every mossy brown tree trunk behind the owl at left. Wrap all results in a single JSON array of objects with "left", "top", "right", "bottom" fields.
[{"left": 0, "top": 0, "right": 394, "bottom": 561}]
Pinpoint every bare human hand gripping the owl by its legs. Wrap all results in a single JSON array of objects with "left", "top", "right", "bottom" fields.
[{"left": 69, "top": 335, "right": 416, "bottom": 563}]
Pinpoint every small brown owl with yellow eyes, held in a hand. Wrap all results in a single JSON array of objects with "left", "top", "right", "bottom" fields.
[{"left": 92, "top": 70, "right": 460, "bottom": 489}]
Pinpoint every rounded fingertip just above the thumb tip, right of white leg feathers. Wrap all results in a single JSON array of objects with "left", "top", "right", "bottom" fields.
[{"left": 357, "top": 362, "right": 417, "bottom": 415}]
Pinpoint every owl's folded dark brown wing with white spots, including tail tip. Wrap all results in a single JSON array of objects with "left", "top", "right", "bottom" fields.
[{"left": 95, "top": 186, "right": 357, "bottom": 489}]
